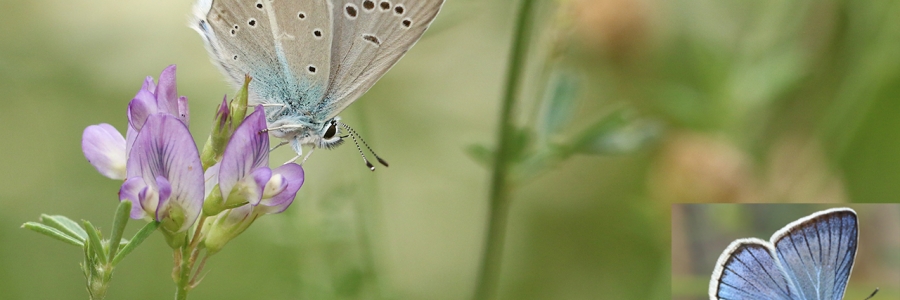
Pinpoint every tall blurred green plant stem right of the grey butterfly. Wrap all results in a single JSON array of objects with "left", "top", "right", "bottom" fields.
[{"left": 474, "top": 0, "right": 535, "bottom": 300}]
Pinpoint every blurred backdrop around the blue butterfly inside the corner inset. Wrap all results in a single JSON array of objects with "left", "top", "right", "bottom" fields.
[{"left": 672, "top": 204, "right": 900, "bottom": 299}]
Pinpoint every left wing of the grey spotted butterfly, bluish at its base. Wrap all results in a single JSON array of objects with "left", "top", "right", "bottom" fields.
[{"left": 193, "top": 0, "right": 333, "bottom": 110}]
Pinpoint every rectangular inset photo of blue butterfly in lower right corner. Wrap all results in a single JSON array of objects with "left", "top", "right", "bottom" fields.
[{"left": 672, "top": 204, "right": 900, "bottom": 300}]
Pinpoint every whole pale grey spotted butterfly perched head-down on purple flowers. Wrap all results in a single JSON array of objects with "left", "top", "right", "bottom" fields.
[{"left": 192, "top": 0, "right": 444, "bottom": 170}]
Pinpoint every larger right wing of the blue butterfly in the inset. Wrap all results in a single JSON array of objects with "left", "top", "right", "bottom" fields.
[{"left": 771, "top": 208, "right": 859, "bottom": 299}]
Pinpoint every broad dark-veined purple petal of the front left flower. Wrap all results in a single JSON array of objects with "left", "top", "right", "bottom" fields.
[{"left": 127, "top": 113, "right": 204, "bottom": 231}]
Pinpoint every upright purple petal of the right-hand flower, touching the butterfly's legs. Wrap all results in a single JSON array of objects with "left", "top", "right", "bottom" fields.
[{"left": 219, "top": 106, "right": 269, "bottom": 195}]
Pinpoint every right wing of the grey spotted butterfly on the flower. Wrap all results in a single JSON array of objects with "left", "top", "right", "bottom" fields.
[{"left": 310, "top": 0, "right": 444, "bottom": 121}]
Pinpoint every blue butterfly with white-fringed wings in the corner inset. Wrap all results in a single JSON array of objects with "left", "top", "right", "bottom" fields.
[{"left": 709, "top": 208, "right": 859, "bottom": 299}]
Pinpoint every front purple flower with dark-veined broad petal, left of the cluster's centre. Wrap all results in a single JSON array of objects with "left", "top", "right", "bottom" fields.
[{"left": 119, "top": 113, "right": 204, "bottom": 234}]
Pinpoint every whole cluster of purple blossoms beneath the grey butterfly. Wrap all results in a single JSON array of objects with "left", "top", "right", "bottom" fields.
[{"left": 82, "top": 65, "right": 304, "bottom": 253}]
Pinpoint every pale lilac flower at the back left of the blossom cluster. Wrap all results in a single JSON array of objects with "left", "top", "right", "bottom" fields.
[{"left": 81, "top": 65, "right": 188, "bottom": 179}]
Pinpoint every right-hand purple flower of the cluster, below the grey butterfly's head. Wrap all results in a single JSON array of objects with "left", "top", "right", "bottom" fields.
[{"left": 204, "top": 106, "right": 304, "bottom": 252}]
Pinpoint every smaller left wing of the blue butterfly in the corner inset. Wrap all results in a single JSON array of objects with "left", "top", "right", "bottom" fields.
[{"left": 709, "top": 238, "right": 798, "bottom": 300}]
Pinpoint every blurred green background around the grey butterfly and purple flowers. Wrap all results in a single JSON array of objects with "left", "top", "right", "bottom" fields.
[{"left": 0, "top": 0, "right": 900, "bottom": 299}]
